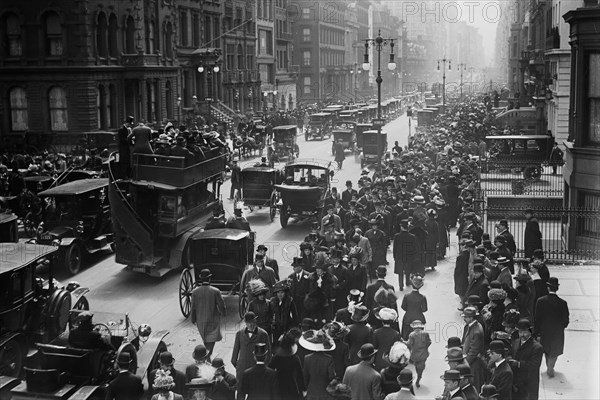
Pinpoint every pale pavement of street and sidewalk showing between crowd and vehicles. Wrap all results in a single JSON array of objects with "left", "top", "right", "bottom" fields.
[{"left": 63, "top": 116, "right": 600, "bottom": 399}]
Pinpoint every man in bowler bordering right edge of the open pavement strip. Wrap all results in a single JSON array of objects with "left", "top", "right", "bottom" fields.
[{"left": 462, "top": 307, "right": 484, "bottom": 390}]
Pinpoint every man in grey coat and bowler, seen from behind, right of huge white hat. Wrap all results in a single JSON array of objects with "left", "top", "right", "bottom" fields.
[{"left": 343, "top": 343, "right": 384, "bottom": 400}]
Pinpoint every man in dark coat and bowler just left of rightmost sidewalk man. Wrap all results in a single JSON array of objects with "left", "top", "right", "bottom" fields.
[{"left": 508, "top": 318, "right": 544, "bottom": 400}]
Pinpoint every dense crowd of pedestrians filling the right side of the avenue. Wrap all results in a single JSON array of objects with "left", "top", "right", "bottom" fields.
[{"left": 116, "top": 100, "right": 569, "bottom": 400}]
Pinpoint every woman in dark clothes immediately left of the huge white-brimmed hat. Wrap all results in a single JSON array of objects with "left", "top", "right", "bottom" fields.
[{"left": 269, "top": 328, "right": 305, "bottom": 400}]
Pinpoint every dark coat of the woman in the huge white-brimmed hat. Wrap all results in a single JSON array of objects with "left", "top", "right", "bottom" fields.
[{"left": 302, "top": 352, "right": 335, "bottom": 400}]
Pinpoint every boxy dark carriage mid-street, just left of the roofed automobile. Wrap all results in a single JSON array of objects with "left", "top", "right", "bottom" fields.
[{"left": 234, "top": 167, "right": 281, "bottom": 222}]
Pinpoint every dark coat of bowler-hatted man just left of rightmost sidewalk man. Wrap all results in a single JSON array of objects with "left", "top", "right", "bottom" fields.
[{"left": 513, "top": 337, "right": 544, "bottom": 400}]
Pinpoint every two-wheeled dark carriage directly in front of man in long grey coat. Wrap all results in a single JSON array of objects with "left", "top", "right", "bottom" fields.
[{"left": 179, "top": 228, "right": 256, "bottom": 318}]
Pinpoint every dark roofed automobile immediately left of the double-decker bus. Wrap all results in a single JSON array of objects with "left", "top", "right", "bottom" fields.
[{"left": 31, "top": 178, "right": 114, "bottom": 275}]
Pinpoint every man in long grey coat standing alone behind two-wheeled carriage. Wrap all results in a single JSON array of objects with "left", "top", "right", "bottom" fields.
[{"left": 190, "top": 269, "right": 226, "bottom": 353}]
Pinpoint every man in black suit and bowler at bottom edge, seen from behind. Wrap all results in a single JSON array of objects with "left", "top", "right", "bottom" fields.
[{"left": 238, "top": 343, "right": 279, "bottom": 400}]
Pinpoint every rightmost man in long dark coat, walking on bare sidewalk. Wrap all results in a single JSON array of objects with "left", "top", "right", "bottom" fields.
[{"left": 533, "top": 276, "right": 569, "bottom": 378}]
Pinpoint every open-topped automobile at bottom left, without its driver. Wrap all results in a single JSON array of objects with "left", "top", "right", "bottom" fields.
[{"left": 4, "top": 310, "right": 169, "bottom": 400}]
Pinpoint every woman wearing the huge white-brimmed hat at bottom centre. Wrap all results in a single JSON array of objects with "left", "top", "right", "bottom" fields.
[{"left": 298, "top": 330, "right": 336, "bottom": 400}]
